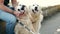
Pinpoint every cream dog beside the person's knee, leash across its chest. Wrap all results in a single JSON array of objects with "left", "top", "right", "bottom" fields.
[{"left": 14, "top": 4, "right": 35, "bottom": 34}]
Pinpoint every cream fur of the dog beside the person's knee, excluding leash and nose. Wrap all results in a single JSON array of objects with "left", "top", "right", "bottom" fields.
[{"left": 14, "top": 5, "right": 35, "bottom": 34}]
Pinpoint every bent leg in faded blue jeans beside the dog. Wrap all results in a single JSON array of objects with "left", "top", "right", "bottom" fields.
[{"left": 0, "top": 10, "right": 16, "bottom": 34}]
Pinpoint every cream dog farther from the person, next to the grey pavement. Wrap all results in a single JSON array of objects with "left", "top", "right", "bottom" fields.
[{"left": 29, "top": 4, "right": 43, "bottom": 34}]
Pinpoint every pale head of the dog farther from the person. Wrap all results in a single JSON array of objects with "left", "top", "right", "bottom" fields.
[{"left": 29, "top": 4, "right": 42, "bottom": 14}]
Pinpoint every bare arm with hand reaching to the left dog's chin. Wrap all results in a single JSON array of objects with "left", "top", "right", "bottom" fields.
[{"left": 0, "top": 0, "right": 20, "bottom": 17}]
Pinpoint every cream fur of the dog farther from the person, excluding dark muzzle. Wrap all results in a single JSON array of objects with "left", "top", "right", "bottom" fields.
[{"left": 29, "top": 6, "right": 43, "bottom": 33}]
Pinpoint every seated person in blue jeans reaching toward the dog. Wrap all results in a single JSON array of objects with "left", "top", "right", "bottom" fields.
[{"left": 0, "top": 0, "right": 21, "bottom": 34}]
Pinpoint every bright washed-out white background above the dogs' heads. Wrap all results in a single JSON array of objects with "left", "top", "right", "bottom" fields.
[{"left": 17, "top": 0, "right": 60, "bottom": 7}]
